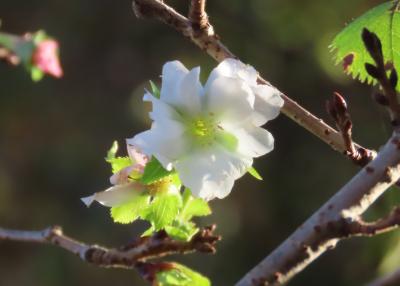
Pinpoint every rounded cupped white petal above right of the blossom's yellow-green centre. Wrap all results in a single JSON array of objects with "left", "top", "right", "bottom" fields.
[{"left": 205, "top": 77, "right": 255, "bottom": 123}]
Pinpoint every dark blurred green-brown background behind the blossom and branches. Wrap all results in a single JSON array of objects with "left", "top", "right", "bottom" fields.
[{"left": 0, "top": 0, "right": 400, "bottom": 286}]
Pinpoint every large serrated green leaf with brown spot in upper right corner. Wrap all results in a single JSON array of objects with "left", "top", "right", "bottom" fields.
[{"left": 331, "top": 0, "right": 400, "bottom": 88}]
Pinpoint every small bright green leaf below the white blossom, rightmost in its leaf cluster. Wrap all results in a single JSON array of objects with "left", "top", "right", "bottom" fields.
[{"left": 180, "top": 189, "right": 211, "bottom": 220}]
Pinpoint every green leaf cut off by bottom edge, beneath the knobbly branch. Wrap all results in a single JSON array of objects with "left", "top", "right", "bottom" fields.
[{"left": 156, "top": 263, "right": 211, "bottom": 286}]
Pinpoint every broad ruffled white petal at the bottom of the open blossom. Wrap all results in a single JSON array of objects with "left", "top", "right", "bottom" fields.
[{"left": 175, "top": 146, "right": 252, "bottom": 200}]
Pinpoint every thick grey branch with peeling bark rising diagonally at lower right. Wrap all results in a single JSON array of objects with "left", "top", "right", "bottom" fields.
[{"left": 236, "top": 132, "right": 400, "bottom": 286}]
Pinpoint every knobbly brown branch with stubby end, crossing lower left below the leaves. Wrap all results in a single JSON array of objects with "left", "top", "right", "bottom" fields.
[{"left": 0, "top": 225, "right": 221, "bottom": 268}]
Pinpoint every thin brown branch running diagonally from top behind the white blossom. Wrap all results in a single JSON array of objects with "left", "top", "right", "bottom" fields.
[{"left": 133, "top": 0, "right": 376, "bottom": 158}]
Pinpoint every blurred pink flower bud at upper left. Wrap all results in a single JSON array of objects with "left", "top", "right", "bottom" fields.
[{"left": 32, "top": 39, "right": 63, "bottom": 78}]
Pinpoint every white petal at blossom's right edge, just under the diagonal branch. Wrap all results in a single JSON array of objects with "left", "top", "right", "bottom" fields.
[{"left": 253, "top": 85, "right": 284, "bottom": 126}]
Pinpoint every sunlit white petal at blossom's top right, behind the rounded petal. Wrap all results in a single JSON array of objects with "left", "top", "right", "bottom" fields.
[{"left": 205, "top": 59, "right": 258, "bottom": 88}]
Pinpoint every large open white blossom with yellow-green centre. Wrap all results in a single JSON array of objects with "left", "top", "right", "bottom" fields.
[{"left": 127, "top": 59, "right": 283, "bottom": 200}]
